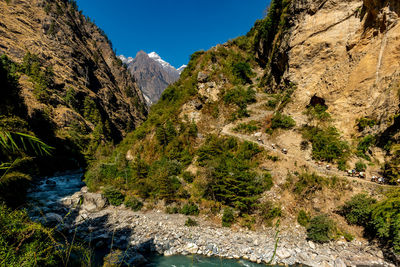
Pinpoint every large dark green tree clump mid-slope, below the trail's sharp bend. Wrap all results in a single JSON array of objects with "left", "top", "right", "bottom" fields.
[{"left": 197, "top": 136, "right": 263, "bottom": 212}]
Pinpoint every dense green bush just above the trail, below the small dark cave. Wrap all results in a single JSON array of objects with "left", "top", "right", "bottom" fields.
[{"left": 303, "top": 127, "right": 349, "bottom": 162}]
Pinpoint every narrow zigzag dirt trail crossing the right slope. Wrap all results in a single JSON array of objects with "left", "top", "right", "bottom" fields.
[{"left": 220, "top": 93, "right": 396, "bottom": 188}]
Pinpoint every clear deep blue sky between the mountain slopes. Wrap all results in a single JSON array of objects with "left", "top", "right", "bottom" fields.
[{"left": 77, "top": 0, "right": 270, "bottom": 67}]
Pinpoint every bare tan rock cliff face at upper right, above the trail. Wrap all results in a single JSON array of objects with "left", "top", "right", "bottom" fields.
[{"left": 256, "top": 0, "right": 400, "bottom": 169}]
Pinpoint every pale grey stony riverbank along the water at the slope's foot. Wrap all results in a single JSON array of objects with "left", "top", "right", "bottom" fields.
[{"left": 34, "top": 187, "right": 394, "bottom": 266}]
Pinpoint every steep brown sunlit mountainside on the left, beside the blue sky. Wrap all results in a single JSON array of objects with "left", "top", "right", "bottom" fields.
[{"left": 0, "top": 0, "right": 147, "bottom": 140}]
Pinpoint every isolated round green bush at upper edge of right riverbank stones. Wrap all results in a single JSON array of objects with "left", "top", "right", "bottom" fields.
[{"left": 307, "top": 214, "right": 337, "bottom": 243}]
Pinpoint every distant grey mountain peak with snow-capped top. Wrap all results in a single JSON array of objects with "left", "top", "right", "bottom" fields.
[{"left": 119, "top": 51, "right": 186, "bottom": 105}]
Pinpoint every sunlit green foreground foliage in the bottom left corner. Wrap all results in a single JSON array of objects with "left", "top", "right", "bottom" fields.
[{"left": 0, "top": 204, "right": 90, "bottom": 266}]
